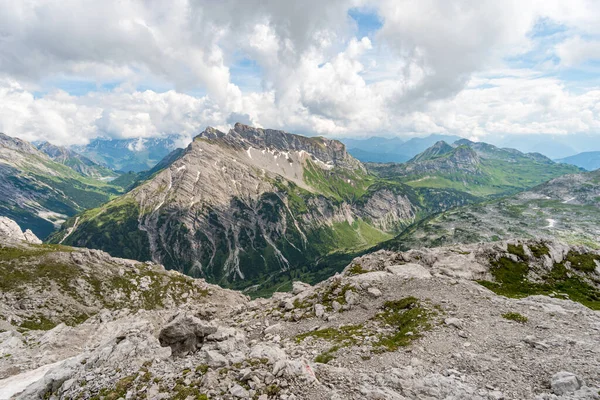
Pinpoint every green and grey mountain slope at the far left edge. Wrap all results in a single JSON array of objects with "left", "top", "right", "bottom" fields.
[{"left": 0, "top": 133, "right": 122, "bottom": 239}]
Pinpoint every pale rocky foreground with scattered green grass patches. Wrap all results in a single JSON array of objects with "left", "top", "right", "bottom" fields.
[{"left": 0, "top": 227, "right": 600, "bottom": 400}]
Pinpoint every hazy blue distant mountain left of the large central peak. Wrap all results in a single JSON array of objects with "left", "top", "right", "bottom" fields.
[{"left": 72, "top": 135, "right": 181, "bottom": 172}]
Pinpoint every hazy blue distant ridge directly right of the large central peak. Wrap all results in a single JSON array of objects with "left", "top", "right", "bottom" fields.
[{"left": 340, "top": 134, "right": 461, "bottom": 163}]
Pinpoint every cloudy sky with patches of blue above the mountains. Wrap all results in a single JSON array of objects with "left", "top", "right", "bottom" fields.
[{"left": 0, "top": 0, "right": 600, "bottom": 145}]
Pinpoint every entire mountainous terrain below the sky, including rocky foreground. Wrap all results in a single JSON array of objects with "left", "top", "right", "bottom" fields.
[{"left": 0, "top": 124, "right": 600, "bottom": 400}]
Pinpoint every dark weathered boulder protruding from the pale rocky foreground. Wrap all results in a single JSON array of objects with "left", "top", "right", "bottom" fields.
[{"left": 158, "top": 314, "right": 217, "bottom": 356}]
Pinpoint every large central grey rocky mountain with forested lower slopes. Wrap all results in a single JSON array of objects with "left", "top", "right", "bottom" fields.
[{"left": 52, "top": 124, "right": 475, "bottom": 288}]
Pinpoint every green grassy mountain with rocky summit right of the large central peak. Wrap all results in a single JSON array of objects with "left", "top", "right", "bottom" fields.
[{"left": 367, "top": 139, "right": 580, "bottom": 197}]
